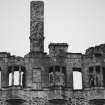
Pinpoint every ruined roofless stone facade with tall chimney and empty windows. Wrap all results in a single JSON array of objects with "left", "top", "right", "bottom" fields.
[{"left": 0, "top": 1, "right": 105, "bottom": 105}]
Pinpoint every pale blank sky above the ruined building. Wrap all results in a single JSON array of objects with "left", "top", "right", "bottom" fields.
[{"left": 0, "top": 0, "right": 105, "bottom": 56}]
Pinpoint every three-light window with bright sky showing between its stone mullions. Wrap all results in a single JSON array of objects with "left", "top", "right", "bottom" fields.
[{"left": 8, "top": 66, "right": 25, "bottom": 87}]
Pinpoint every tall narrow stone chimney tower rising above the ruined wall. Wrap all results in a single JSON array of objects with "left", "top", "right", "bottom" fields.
[{"left": 30, "top": 1, "right": 44, "bottom": 52}]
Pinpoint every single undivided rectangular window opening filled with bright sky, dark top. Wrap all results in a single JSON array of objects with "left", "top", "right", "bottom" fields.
[{"left": 73, "top": 68, "right": 82, "bottom": 90}]
